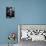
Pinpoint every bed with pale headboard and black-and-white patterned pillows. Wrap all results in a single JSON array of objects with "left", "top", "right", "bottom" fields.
[{"left": 18, "top": 24, "right": 46, "bottom": 46}]
